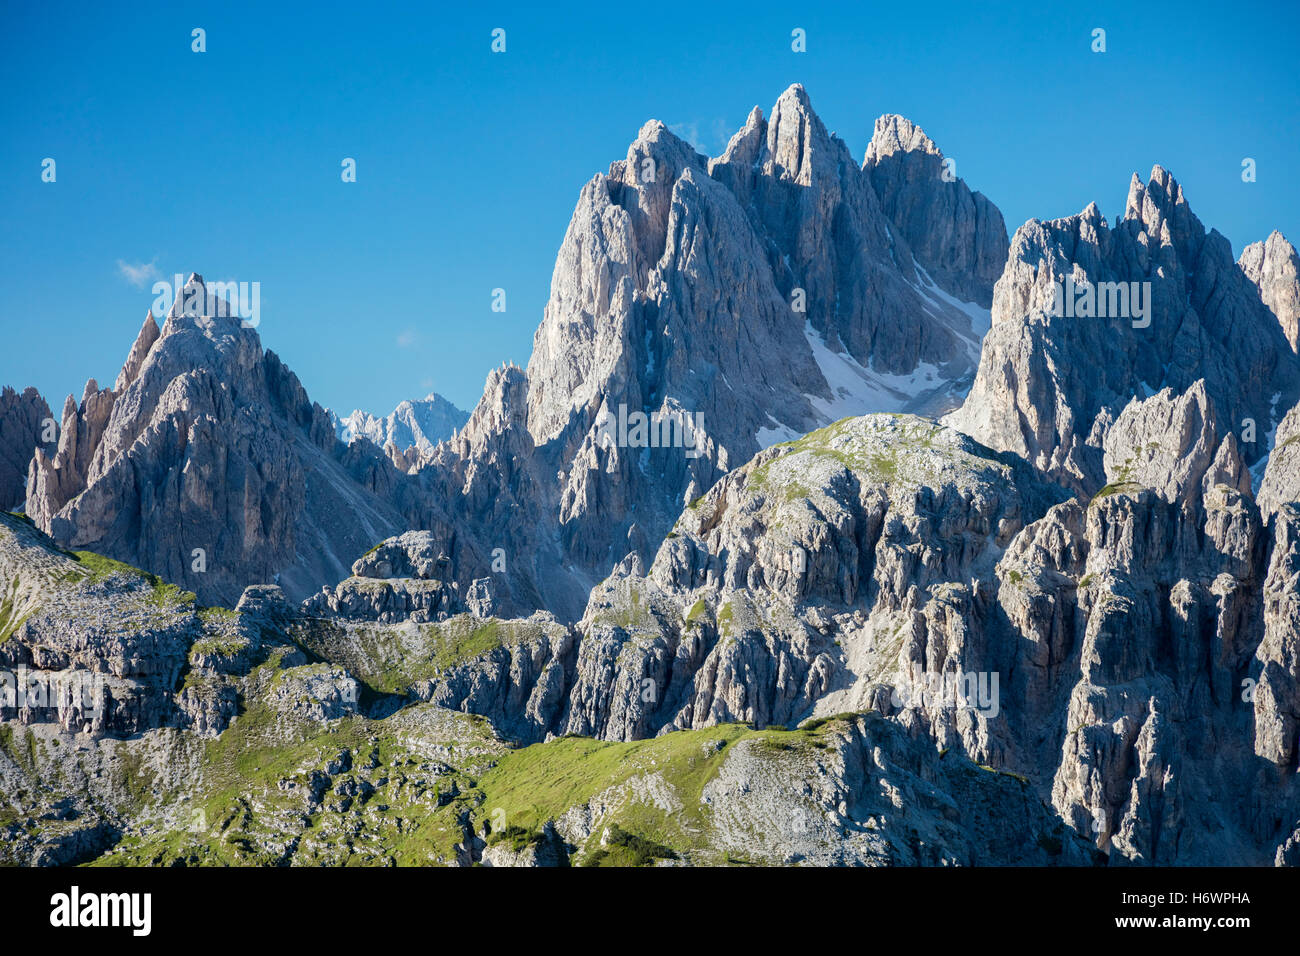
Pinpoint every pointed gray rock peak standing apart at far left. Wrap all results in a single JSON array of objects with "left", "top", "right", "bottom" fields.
[{"left": 29, "top": 276, "right": 406, "bottom": 605}]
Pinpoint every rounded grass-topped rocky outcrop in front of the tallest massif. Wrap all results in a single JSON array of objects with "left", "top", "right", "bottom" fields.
[{"left": 553, "top": 416, "right": 1061, "bottom": 758}]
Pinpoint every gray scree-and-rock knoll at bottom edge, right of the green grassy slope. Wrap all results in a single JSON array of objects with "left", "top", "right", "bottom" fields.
[{"left": 703, "top": 715, "right": 1100, "bottom": 866}]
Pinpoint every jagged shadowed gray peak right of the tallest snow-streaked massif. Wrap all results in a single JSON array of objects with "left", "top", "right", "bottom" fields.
[{"left": 946, "top": 166, "right": 1300, "bottom": 496}]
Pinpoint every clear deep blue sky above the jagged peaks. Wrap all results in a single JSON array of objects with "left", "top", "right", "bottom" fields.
[{"left": 0, "top": 0, "right": 1300, "bottom": 414}]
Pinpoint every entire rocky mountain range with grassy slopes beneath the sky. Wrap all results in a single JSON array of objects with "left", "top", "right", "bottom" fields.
[{"left": 0, "top": 86, "right": 1300, "bottom": 865}]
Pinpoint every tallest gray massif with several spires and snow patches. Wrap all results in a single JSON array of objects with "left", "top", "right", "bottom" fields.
[{"left": 416, "top": 86, "right": 1005, "bottom": 619}]
